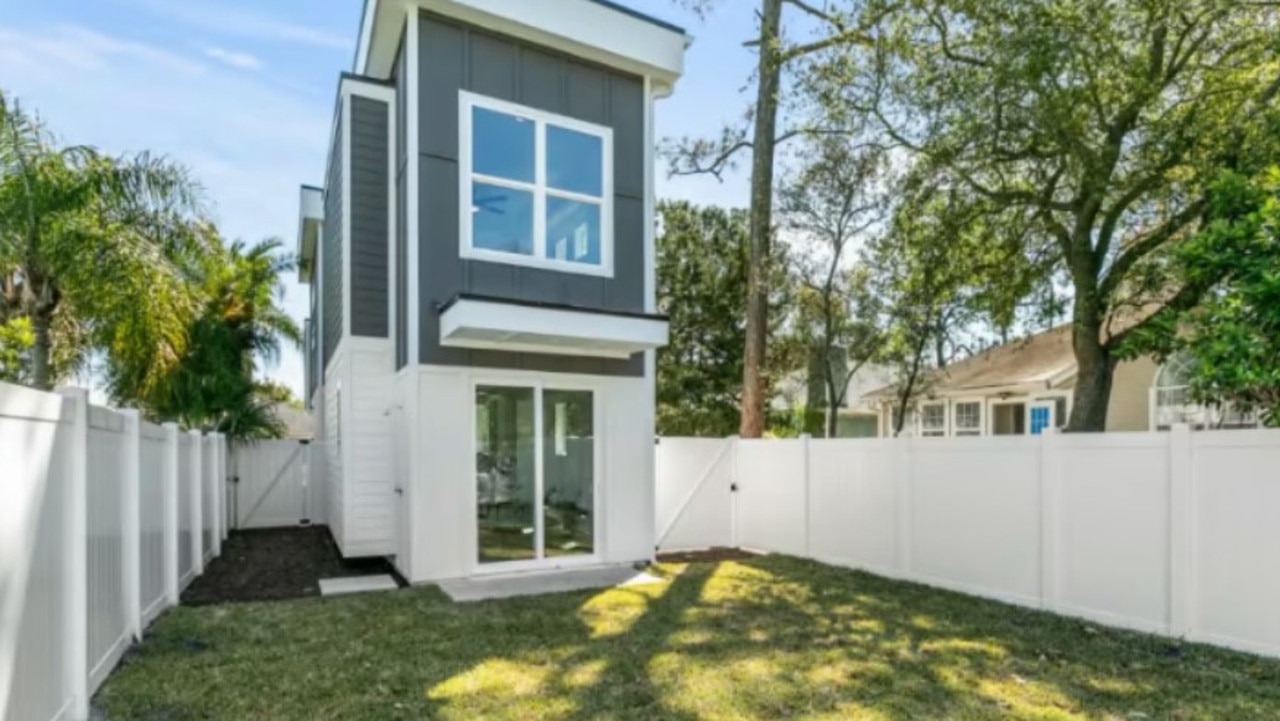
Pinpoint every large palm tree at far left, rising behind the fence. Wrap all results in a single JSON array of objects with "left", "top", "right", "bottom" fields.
[{"left": 0, "top": 93, "right": 207, "bottom": 389}]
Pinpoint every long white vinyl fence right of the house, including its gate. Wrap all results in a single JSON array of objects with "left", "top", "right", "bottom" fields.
[{"left": 657, "top": 426, "right": 1280, "bottom": 656}]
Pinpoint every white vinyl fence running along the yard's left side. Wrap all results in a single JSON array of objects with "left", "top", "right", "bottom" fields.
[{"left": 0, "top": 383, "right": 227, "bottom": 721}]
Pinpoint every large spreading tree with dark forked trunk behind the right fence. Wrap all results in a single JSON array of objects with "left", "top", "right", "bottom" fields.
[{"left": 804, "top": 0, "right": 1280, "bottom": 430}]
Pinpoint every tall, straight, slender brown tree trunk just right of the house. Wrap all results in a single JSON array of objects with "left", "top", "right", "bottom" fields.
[{"left": 739, "top": 0, "right": 783, "bottom": 438}]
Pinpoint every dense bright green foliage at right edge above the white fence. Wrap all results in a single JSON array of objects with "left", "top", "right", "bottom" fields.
[{"left": 1121, "top": 169, "right": 1280, "bottom": 426}]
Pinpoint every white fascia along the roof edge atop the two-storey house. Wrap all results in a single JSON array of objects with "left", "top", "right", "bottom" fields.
[{"left": 355, "top": 0, "right": 692, "bottom": 87}]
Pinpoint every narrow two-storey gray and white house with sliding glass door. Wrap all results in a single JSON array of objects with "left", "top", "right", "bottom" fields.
[{"left": 300, "top": 0, "right": 690, "bottom": 583}]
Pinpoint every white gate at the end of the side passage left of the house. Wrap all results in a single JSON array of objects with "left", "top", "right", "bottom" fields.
[{"left": 232, "top": 441, "right": 324, "bottom": 529}]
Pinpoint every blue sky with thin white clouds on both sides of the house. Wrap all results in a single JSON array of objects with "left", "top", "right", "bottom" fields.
[{"left": 0, "top": 0, "right": 754, "bottom": 399}]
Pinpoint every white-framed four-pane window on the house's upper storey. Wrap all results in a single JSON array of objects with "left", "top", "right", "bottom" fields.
[{"left": 458, "top": 91, "right": 613, "bottom": 278}]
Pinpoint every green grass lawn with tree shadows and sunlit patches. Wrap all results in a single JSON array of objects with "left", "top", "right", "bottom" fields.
[{"left": 96, "top": 557, "right": 1280, "bottom": 721}]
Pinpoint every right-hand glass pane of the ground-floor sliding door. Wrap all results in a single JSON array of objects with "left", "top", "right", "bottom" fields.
[{"left": 543, "top": 391, "right": 595, "bottom": 557}]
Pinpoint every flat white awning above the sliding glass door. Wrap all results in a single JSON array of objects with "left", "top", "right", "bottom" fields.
[{"left": 440, "top": 298, "right": 669, "bottom": 357}]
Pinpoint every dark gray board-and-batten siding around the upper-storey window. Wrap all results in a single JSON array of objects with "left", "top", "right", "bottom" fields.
[{"left": 407, "top": 13, "right": 645, "bottom": 377}]
